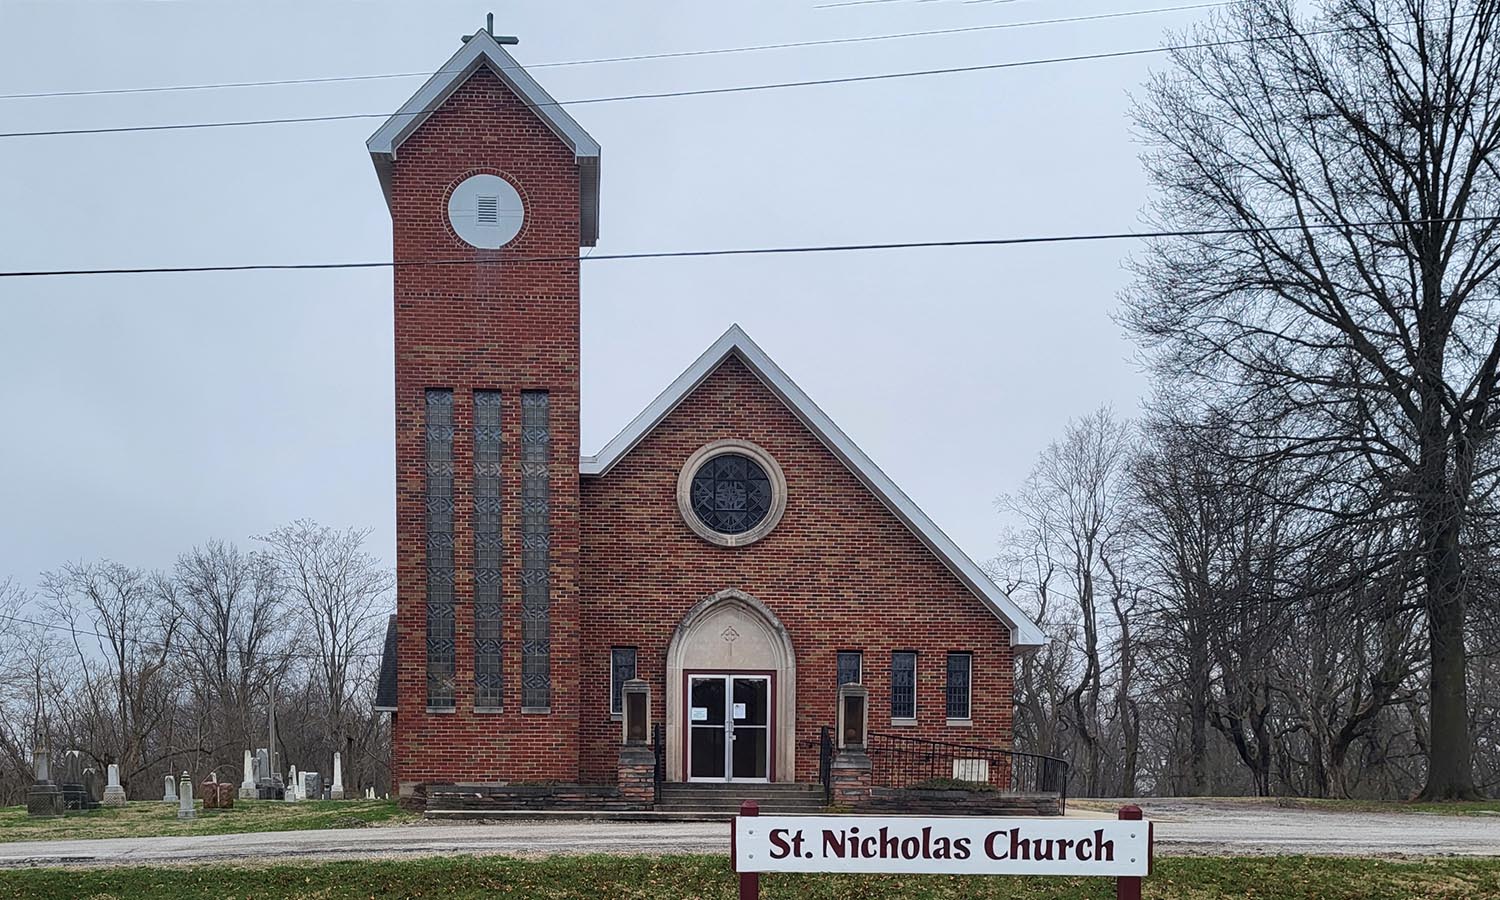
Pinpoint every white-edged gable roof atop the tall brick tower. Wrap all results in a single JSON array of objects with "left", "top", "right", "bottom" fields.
[{"left": 365, "top": 29, "right": 599, "bottom": 248}]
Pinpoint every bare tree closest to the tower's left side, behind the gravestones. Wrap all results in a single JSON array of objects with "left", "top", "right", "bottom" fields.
[{"left": 260, "top": 519, "right": 393, "bottom": 780}]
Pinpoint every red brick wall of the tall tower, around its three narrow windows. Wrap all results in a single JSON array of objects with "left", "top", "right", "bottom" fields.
[{"left": 390, "top": 69, "right": 579, "bottom": 785}]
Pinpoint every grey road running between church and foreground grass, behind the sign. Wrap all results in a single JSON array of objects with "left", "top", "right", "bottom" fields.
[{"left": 0, "top": 800, "right": 1500, "bottom": 867}]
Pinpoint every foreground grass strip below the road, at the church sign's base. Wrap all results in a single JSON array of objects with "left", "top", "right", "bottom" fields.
[{"left": 0, "top": 857, "right": 1500, "bottom": 900}]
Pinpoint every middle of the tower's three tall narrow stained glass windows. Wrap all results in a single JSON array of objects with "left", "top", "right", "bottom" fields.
[{"left": 474, "top": 390, "right": 503, "bottom": 710}]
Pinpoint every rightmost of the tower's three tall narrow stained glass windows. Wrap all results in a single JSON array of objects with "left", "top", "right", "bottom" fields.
[{"left": 521, "top": 390, "right": 552, "bottom": 710}]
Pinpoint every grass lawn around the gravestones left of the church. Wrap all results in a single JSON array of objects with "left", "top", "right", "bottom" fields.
[{"left": 0, "top": 800, "right": 417, "bottom": 842}]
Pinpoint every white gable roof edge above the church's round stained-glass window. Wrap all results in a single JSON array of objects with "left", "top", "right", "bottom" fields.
[{"left": 579, "top": 326, "right": 1049, "bottom": 648}]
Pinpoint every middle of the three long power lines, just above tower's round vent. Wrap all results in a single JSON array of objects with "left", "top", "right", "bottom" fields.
[{"left": 0, "top": 38, "right": 1251, "bottom": 138}]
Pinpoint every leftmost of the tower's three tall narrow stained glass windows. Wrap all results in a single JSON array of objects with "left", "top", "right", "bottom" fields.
[{"left": 426, "top": 390, "right": 455, "bottom": 710}]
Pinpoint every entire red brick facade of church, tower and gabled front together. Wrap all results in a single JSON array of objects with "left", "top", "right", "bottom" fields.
[{"left": 389, "top": 54, "right": 1013, "bottom": 792}]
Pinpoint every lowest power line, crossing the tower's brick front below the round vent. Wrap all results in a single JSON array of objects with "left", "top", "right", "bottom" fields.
[{"left": 0, "top": 216, "right": 1500, "bottom": 278}]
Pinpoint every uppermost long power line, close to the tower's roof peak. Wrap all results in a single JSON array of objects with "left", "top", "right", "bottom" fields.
[{"left": 0, "top": 0, "right": 1229, "bottom": 101}]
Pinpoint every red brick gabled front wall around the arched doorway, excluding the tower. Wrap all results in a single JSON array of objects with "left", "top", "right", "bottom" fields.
[{"left": 579, "top": 359, "right": 1013, "bottom": 783}]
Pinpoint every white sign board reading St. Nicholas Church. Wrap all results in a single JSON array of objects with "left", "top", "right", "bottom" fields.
[{"left": 734, "top": 816, "right": 1151, "bottom": 876}]
